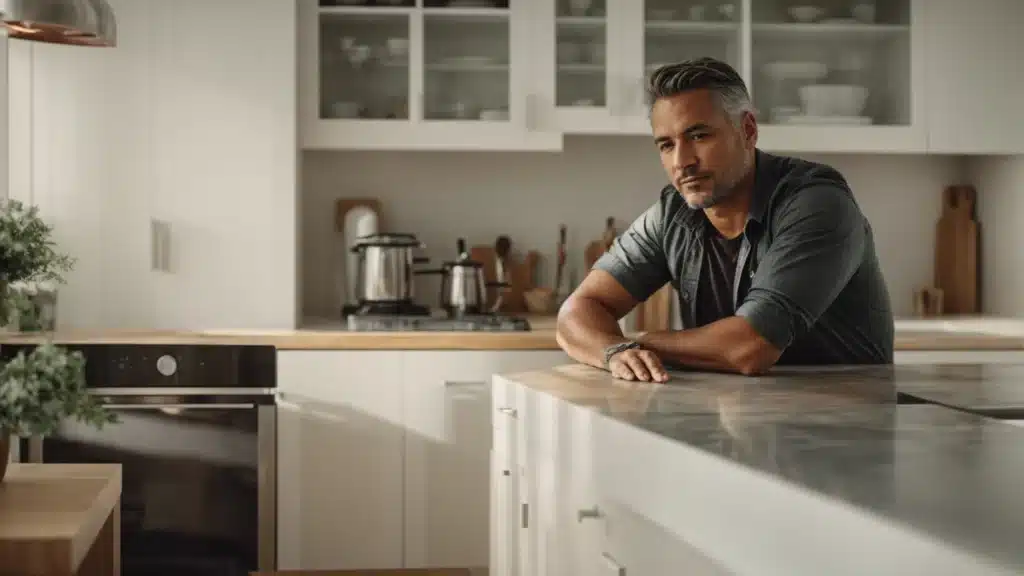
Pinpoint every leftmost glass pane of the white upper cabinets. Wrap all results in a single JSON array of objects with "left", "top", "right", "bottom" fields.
[{"left": 319, "top": 12, "right": 410, "bottom": 120}]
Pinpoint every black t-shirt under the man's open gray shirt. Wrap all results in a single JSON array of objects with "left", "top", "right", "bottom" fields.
[{"left": 696, "top": 222, "right": 743, "bottom": 327}]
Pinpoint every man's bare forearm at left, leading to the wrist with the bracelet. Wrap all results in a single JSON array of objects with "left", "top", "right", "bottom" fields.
[{"left": 556, "top": 298, "right": 627, "bottom": 368}]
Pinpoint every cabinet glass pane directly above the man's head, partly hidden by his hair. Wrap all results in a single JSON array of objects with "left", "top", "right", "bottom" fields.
[{"left": 644, "top": 0, "right": 740, "bottom": 89}]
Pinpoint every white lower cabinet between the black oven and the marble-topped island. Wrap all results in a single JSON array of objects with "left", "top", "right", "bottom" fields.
[{"left": 278, "top": 351, "right": 570, "bottom": 571}]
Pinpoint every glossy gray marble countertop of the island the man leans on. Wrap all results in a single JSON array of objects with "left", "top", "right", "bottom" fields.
[{"left": 507, "top": 365, "right": 1024, "bottom": 573}]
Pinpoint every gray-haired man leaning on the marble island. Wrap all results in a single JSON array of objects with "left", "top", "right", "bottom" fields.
[{"left": 557, "top": 58, "right": 893, "bottom": 381}]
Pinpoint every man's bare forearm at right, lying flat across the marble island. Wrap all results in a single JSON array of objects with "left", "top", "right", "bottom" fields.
[{"left": 638, "top": 316, "right": 778, "bottom": 374}]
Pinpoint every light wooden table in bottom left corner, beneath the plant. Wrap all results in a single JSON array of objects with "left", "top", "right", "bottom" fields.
[{"left": 0, "top": 463, "right": 121, "bottom": 575}]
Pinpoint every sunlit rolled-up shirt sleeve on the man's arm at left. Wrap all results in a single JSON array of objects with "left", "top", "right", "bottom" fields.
[{"left": 594, "top": 194, "right": 671, "bottom": 301}]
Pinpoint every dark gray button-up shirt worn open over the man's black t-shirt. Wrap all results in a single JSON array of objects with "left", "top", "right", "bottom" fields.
[{"left": 594, "top": 150, "right": 894, "bottom": 364}]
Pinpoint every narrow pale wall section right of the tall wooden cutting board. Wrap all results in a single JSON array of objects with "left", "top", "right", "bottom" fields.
[{"left": 968, "top": 156, "right": 1024, "bottom": 317}]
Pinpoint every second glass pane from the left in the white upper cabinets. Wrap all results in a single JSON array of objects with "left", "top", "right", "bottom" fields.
[{"left": 423, "top": 0, "right": 511, "bottom": 122}]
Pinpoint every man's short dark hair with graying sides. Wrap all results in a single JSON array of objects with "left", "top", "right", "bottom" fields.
[{"left": 645, "top": 57, "right": 754, "bottom": 124}]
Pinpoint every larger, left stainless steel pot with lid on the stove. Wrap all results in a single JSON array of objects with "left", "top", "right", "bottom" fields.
[{"left": 352, "top": 233, "right": 429, "bottom": 304}]
